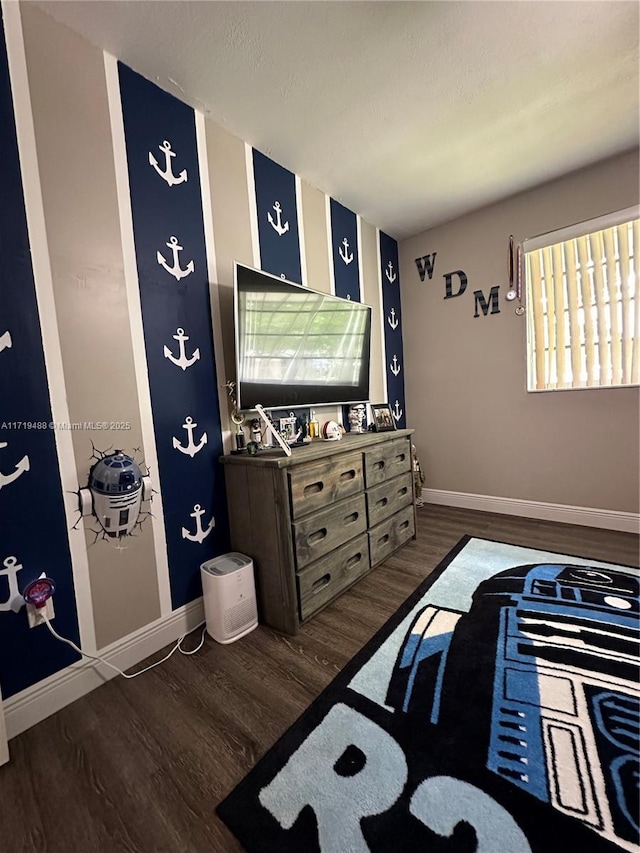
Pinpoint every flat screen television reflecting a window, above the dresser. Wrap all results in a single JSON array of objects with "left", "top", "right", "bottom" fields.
[{"left": 234, "top": 262, "right": 371, "bottom": 411}]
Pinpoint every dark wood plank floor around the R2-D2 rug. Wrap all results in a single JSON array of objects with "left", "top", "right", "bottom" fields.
[{"left": 0, "top": 506, "right": 639, "bottom": 853}]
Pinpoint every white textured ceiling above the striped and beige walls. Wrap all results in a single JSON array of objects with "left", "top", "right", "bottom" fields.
[{"left": 35, "top": 0, "right": 640, "bottom": 238}]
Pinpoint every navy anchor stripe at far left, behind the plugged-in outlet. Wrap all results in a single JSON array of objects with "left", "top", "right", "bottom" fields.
[{"left": 0, "top": 10, "right": 79, "bottom": 699}]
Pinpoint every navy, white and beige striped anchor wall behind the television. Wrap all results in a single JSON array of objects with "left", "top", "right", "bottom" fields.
[{"left": 0, "top": 4, "right": 405, "bottom": 736}]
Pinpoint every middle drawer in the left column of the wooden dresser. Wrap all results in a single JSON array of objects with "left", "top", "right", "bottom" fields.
[{"left": 292, "top": 494, "right": 367, "bottom": 569}]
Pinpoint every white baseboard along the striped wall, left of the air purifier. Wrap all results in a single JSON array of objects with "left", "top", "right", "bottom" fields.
[{"left": 4, "top": 598, "right": 204, "bottom": 738}]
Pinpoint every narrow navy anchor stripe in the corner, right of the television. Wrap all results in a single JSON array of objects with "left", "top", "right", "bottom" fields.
[{"left": 374, "top": 231, "right": 407, "bottom": 429}]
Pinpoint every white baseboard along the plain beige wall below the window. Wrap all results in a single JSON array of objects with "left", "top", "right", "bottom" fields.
[{"left": 422, "top": 489, "right": 640, "bottom": 533}]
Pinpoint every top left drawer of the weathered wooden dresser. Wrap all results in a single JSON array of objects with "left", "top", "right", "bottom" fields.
[{"left": 289, "top": 452, "right": 364, "bottom": 518}]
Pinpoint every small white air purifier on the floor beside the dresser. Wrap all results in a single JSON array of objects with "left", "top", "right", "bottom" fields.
[{"left": 200, "top": 551, "right": 258, "bottom": 643}]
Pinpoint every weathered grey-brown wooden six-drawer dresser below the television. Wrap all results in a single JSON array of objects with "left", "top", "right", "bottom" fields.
[{"left": 221, "top": 429, "right": 416, "bottom": 634}]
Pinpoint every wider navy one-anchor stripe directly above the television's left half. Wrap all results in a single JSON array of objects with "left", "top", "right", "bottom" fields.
[{"left": 253, "top": 148, "right": 302, "bottom": 284}]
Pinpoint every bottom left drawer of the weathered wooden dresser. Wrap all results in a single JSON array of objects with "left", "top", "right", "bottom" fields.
[{"left": 297, "top": 533, "right": 369, "bottom": 619}]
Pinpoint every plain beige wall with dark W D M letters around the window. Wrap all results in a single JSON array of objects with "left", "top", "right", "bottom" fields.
[{"left": 400, "top": 151, "right": 640, "bottom": 512}]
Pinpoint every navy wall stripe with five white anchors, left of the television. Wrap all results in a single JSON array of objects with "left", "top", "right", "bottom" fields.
[{"left": 118, "top": 63, "right": 229, "bottom": 608}]
